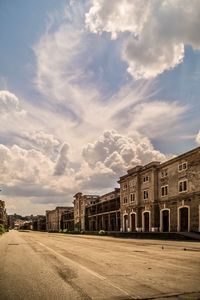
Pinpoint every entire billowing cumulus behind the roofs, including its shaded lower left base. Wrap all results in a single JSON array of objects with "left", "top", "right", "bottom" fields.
[{"left": 70, "top": 130, "right": 171, "bottom": 194}]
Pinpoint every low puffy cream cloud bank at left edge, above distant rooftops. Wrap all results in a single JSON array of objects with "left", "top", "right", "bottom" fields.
[{"left": 0, "top": 144, "right": 76, "bottom": 202}]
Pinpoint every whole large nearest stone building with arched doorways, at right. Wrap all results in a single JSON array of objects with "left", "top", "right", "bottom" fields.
[{"left": 119, "top": 147, "right": 200, "bottom": 232}]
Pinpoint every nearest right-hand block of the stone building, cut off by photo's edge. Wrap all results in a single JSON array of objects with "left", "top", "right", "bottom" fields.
[{"left": 158, "top": 147, "right": 200, "bottom": 231}]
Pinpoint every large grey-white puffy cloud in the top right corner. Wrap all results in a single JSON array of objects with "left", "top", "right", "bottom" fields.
[{"left": 85, "top": 0, "right": 200, "bottom": 79}]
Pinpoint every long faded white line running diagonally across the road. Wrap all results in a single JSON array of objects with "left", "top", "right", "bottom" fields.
[{"left": 36, "top": 241, "right": 141, "bottom": 299}]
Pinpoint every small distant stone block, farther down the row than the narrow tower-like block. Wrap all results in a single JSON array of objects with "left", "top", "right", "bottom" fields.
[{"left": 46, "top": 206, "right": 70, "bottom": 232}]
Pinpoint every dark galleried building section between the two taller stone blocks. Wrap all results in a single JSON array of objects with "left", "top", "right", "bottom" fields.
[{"left": 85, "top": 188, "right": 120, "bottom": 231}]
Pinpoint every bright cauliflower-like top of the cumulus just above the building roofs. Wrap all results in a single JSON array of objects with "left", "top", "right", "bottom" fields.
[{"left": 83, "top": 130, "right": 166, "bottom": 176}]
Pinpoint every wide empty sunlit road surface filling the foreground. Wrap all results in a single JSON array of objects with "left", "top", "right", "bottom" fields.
[{"left": 0, "top": 231, "right": 200, "bottom": 300}]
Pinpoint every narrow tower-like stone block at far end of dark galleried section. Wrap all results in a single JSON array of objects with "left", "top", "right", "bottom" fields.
[{"left": 73, "top": 193, "right": 99, "bottom": 231}]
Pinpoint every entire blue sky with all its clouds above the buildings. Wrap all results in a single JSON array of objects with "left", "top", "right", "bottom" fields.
[{"left": 0, "top": 0, "right": 200, "bottom": 214}]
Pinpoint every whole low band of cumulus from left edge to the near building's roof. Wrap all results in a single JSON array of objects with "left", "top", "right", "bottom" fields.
[{"left": 0, "top": 125, "right": 169, "bottom": 212}]
